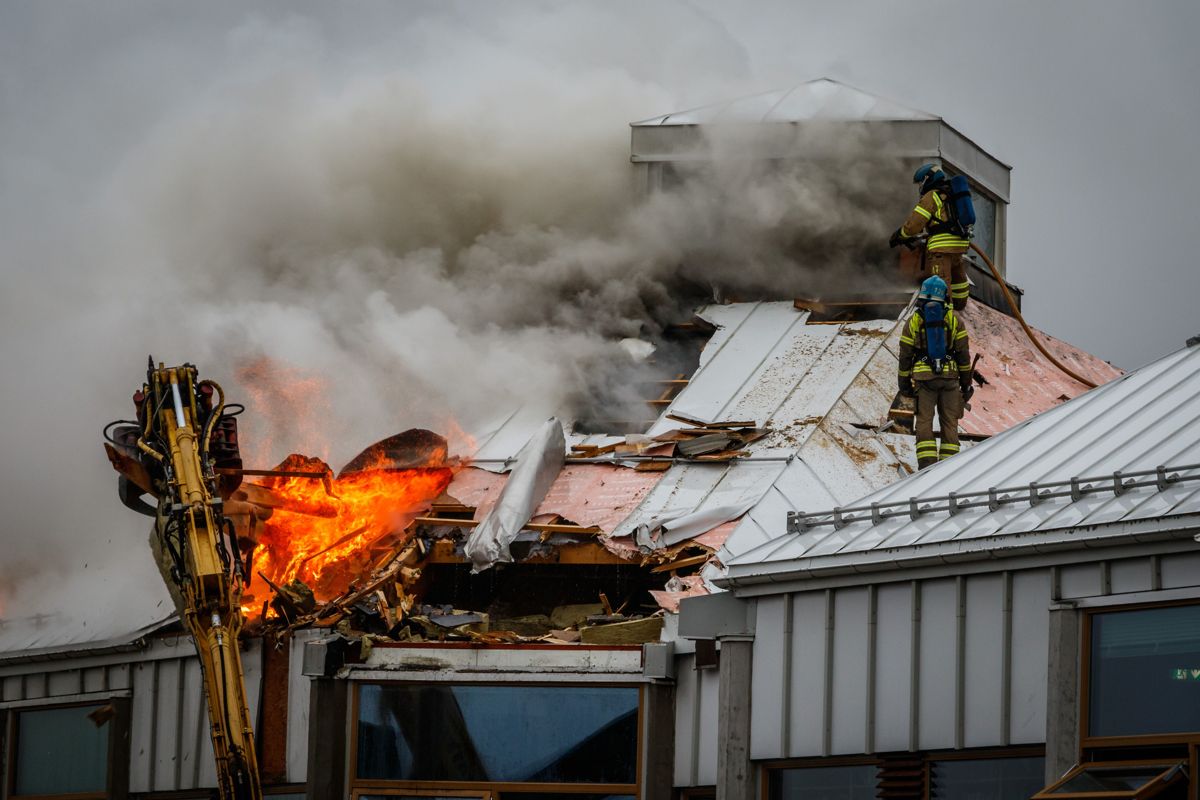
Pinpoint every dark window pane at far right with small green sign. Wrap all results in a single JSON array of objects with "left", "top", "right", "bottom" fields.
[{"left": 1087, "top": 606, "right": 1200, "bottom": 736}]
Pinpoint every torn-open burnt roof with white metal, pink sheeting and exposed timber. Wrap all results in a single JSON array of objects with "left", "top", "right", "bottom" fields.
[{"left": 0, "top": 301, "right": 1118, "bottom": 658}]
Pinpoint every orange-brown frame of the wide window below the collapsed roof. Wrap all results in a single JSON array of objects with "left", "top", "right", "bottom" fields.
[{"left": 348, "top": 680, "right": 646, "bottom": 800}]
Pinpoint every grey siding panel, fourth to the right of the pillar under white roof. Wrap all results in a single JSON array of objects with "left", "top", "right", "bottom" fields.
[{"left": 874, "top": 583, "right": 913, "bottom": 752}]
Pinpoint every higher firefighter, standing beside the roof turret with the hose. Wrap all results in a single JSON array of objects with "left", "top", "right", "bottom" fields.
[{"left": 888, "top": 164, "right": 971, "bottom": 311}]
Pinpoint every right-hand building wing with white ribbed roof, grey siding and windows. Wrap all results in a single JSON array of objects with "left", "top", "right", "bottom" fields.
[{"left": 677, "top": 345, "right": 1200, "bottom": 800}]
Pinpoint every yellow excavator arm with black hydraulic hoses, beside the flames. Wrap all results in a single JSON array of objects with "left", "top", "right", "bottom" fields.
[{"left": 106, "top": 359, "right": 263, "bottom": 800}]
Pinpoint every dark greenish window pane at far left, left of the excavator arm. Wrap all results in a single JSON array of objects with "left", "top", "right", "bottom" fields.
[{"left": 16, "top": 705, "right": 108, "bottom": 794}]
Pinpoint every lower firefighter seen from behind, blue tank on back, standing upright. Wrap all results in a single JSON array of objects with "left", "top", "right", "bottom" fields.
[{"left": 898, "top": 275, "right": 974, "bottom": 469}]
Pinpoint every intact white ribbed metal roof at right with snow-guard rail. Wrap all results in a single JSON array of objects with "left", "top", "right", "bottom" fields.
[{"left": 727, "top": 345, "right": 1200, "bottom": 585}]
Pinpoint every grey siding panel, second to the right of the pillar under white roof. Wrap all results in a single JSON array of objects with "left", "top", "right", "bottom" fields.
[{"left": 782, "top": 591, "right": 826, "bottom": 756}]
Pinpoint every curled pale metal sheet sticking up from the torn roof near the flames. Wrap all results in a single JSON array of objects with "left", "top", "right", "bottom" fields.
[{"left": 464, "top": 417, "right": 566, "bottom": 572}]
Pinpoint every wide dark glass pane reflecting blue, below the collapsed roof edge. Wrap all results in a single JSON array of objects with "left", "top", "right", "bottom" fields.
[{"left": 358, "top": 685, "right": 637, "bottom": 783}]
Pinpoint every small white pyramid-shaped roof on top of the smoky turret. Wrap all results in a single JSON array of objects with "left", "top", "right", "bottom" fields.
[{"left": 632, "top": 78, "right": 941, "bottom": 127}]
